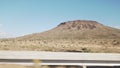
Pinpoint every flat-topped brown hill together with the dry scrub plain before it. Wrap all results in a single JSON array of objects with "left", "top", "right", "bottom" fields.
[{"left": 0, "top": 20, "right": 120, "bottom": 53}]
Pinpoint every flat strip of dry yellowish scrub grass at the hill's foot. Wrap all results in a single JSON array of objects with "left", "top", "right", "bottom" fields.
[{"left": 0, "top": 39, "right": 120, "bottom": 53}]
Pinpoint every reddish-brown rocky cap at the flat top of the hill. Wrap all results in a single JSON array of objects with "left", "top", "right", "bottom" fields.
[{"left": 58, "top": 20, "right": 103, "bottom": 30}]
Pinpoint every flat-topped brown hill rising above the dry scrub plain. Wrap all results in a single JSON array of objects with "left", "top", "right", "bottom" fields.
[{"left": 18, "top": 20, "right": 120, "bottom": 40}]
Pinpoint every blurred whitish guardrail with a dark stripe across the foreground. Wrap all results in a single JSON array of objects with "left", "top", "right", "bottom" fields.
[{"left": 0, "top": 51, "right": 120, "bottom": 68}]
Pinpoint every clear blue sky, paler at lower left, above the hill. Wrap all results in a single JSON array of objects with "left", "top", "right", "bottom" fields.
[{"left": 0, "top": 0, "right": 120, "bottom": 37}]
